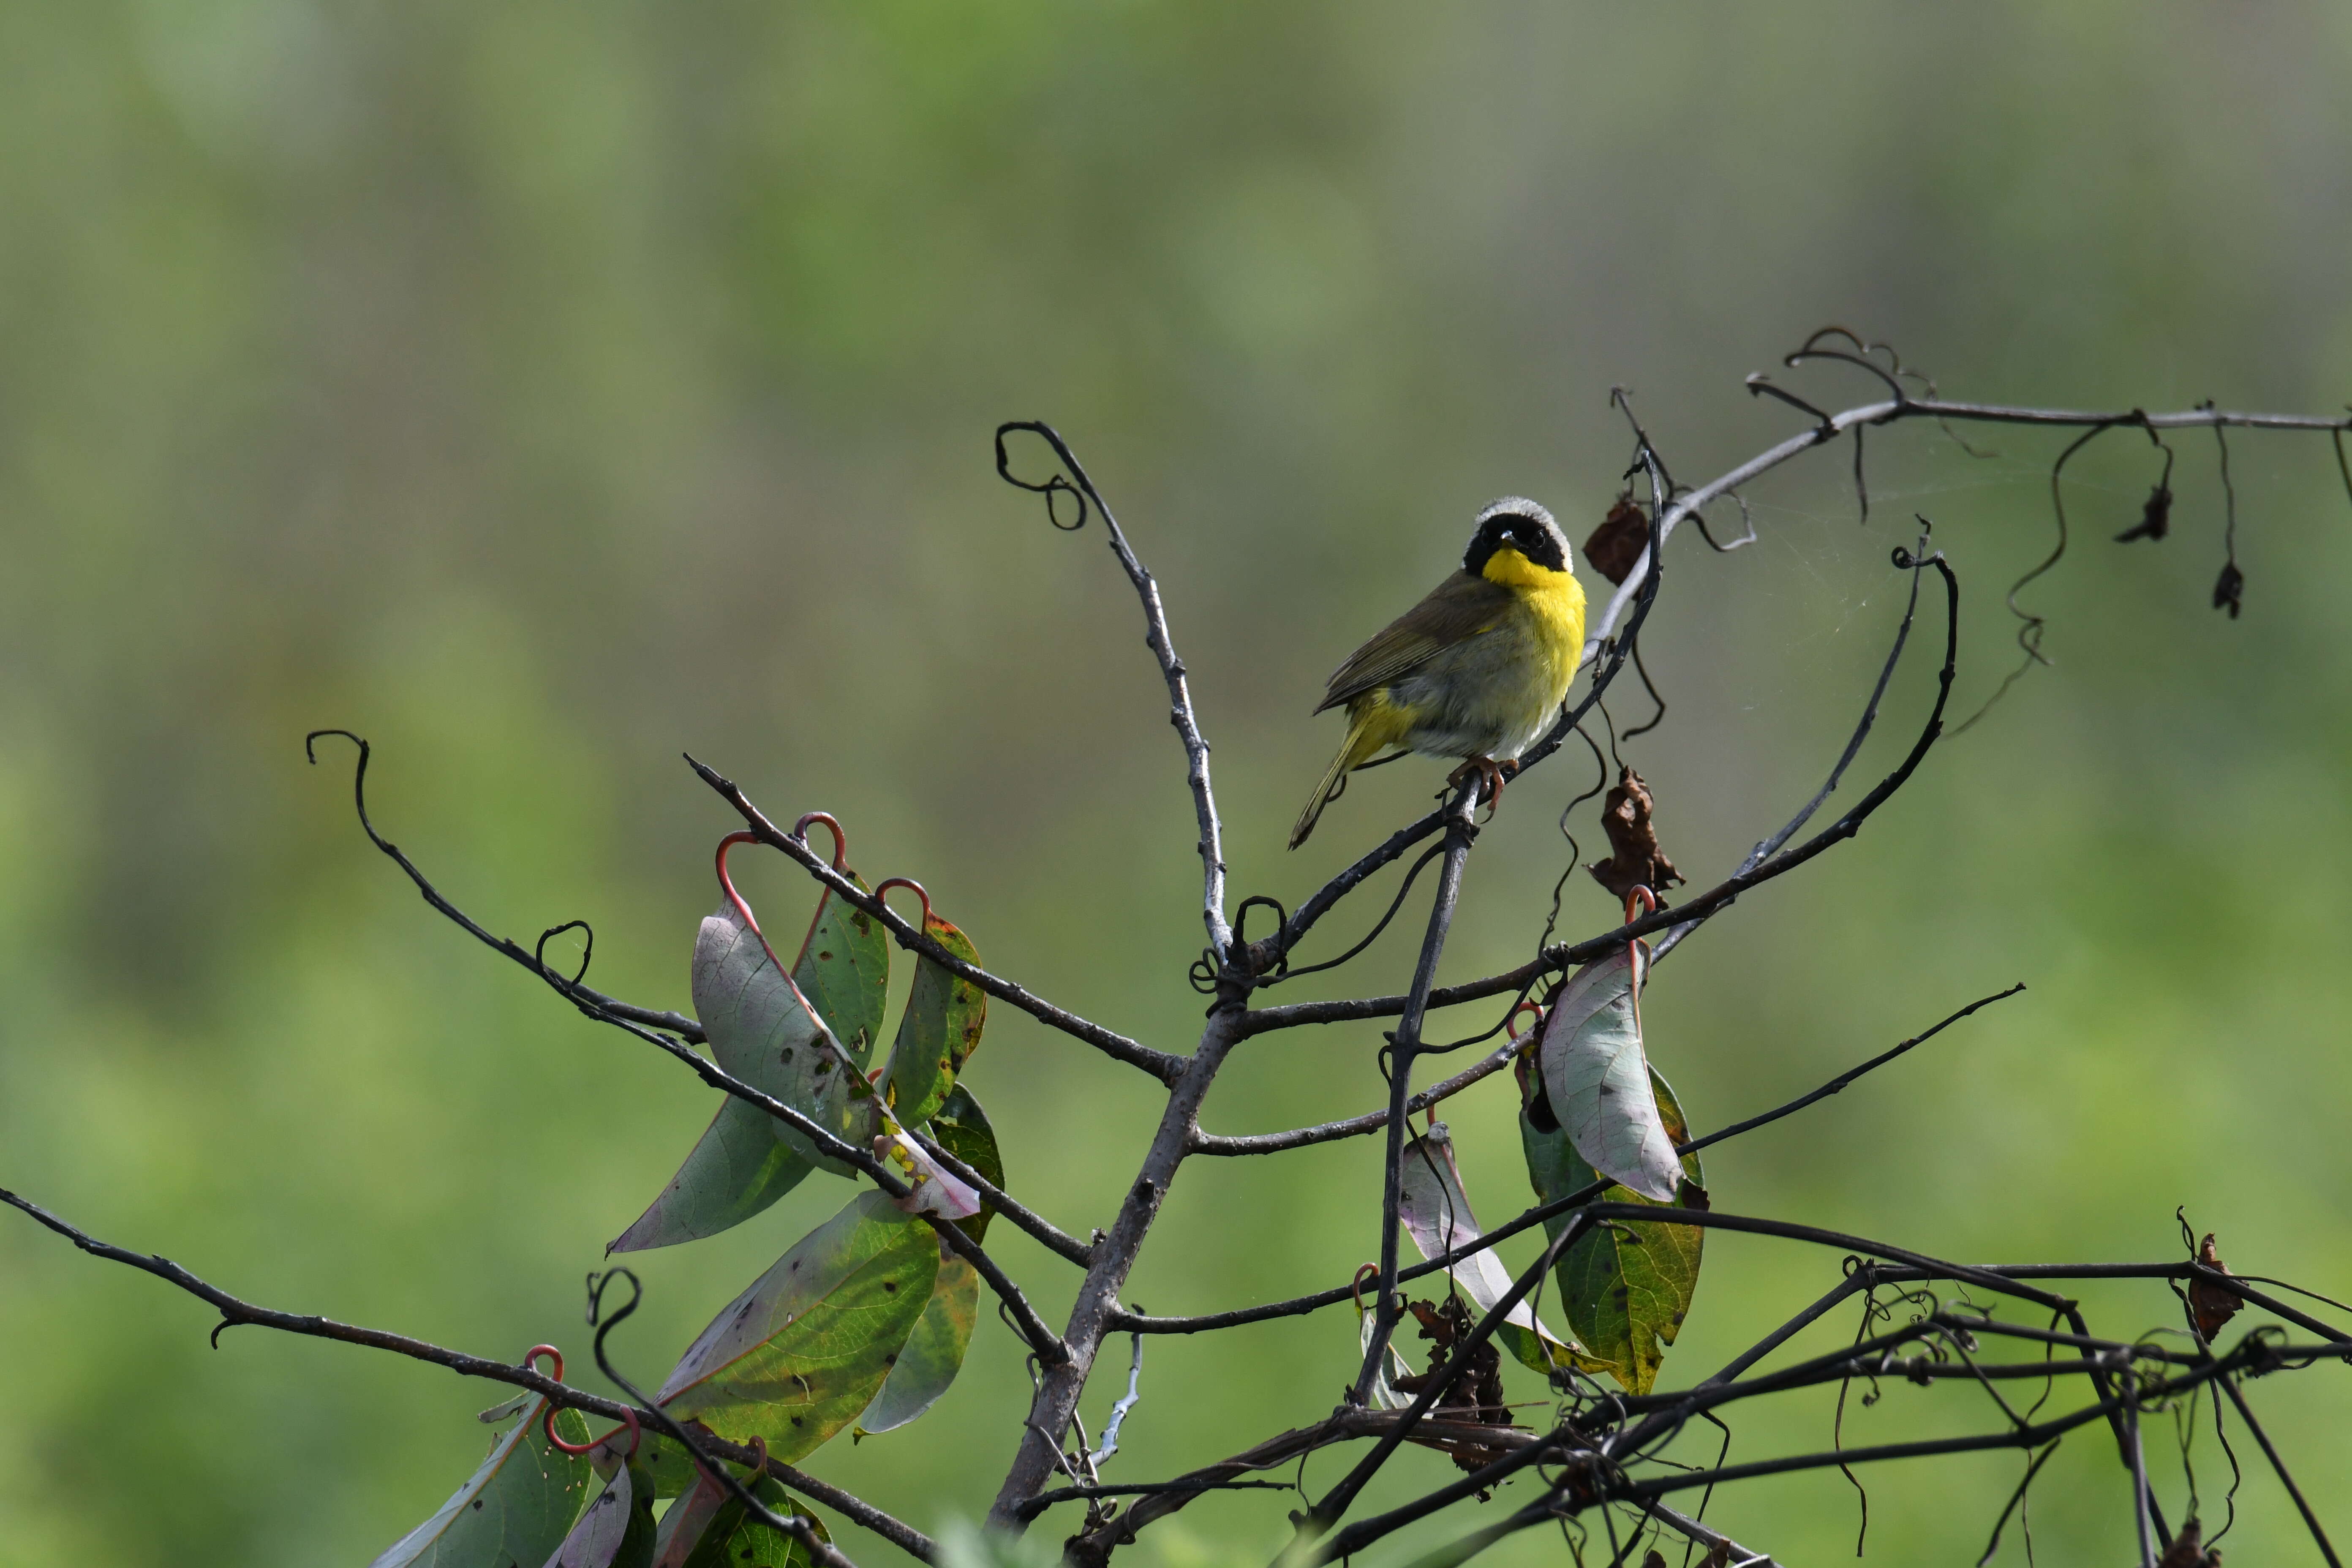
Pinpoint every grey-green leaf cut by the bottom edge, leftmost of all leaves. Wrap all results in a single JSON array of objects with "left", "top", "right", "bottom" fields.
[{"left": 369, "top": 1399, "right": 593, "bottom": 1568}]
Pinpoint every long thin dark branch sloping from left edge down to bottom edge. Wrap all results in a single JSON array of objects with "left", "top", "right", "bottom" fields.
[{"left": 0, "top": 1187, "right": 939, "bottom": 1563}]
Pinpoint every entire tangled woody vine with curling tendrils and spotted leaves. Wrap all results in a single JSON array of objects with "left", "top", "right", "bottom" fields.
[{"left": 0, "top": 329, "right": 2352, "bottom": 1568}]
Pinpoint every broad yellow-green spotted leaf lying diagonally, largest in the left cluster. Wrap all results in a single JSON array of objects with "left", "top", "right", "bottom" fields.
[{"left": 659, "top": 1192, "right": 939, "bottom": 1465}]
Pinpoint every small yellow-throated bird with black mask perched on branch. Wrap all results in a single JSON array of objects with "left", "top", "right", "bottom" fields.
[{"left": 1291, "top": 496, "right": 1585, "bottom": 849}]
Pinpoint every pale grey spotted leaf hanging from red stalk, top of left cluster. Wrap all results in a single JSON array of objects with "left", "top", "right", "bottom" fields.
[{"left": 694, "top": 900, "right": 877, "bottom": 1176}]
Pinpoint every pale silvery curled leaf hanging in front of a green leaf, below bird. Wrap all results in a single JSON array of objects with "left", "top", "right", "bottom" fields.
[{"left": 1538, "top": 943, "right": 1680, "bottom": 1203}]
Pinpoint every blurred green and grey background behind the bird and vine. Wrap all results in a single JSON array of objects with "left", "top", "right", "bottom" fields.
[{"left": 0, "top": 0, "right": 2352, "bottom": 1568}]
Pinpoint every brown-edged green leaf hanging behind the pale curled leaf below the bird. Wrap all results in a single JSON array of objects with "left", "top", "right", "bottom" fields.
[{"left": 1519, "top": 1067, "right": 1707, "bottom": 1394}]
